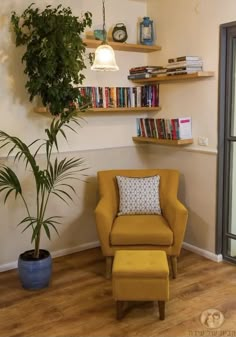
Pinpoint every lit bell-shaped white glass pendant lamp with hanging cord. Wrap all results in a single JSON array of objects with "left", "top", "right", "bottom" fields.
[{"left": 91, "top": 0, "right": 119, "bottom": 71}]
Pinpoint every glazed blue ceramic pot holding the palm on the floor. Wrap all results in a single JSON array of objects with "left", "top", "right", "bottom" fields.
[{"left": 18, "top": 250, "right": 52, "bottom": 290}]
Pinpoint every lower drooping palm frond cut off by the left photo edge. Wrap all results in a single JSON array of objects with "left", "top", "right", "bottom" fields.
[{"left": 0, "top": 165, "right": 22, "bottom": 203}]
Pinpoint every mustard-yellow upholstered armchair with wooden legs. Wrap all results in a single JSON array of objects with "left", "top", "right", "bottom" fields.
[{"left": 95, "top": 169, "right": 188, "bottom": 278}]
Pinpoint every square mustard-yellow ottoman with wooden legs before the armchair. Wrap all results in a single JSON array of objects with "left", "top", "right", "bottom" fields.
[{"left": 112, "top": 250, "right": 169, "bottom": 320}]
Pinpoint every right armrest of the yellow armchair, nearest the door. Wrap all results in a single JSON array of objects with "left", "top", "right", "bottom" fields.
[{"left": 162, "top": 199, "right": 188, "bottom": 256}]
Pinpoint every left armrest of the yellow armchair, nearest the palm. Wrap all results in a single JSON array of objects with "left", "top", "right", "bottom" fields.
[{"left": 95, "top": 198, "right": 116, "bottom": 256}]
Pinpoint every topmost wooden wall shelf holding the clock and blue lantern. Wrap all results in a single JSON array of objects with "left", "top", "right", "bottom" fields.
[{"left": 83, "top": 39, "right": 161, "bottom": 53}]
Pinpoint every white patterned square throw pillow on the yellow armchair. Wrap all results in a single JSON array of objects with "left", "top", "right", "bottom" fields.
[{"left": 116, "top": 176, "right": 161, "bottom": 215}]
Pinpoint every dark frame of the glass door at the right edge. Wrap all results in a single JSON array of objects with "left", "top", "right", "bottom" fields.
[{"left": 216, "top": 21, "right": 236, "bottom": 262}]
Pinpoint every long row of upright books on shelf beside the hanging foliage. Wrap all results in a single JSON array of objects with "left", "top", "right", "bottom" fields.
[{"left": 78, "top": 84, "right": 159, "bottom": 108}]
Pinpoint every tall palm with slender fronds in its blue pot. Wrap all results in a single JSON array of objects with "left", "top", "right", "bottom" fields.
[{"left": 0, "top": 110, "right": 85, "bottom": 289}]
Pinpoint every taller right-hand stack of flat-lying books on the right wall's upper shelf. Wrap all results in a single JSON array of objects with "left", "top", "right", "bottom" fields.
[{"left": 166, "top": 56, "right": 203, "bottom": 75}]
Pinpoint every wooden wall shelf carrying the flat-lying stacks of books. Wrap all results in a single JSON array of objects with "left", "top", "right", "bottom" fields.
[{"left": 131, "top": 71, "right": 215, "bottom": 83}]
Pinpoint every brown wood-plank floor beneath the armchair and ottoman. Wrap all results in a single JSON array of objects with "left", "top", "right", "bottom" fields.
[{"left": 0, "top": 249, "right": 236, "bottom": 337}]
